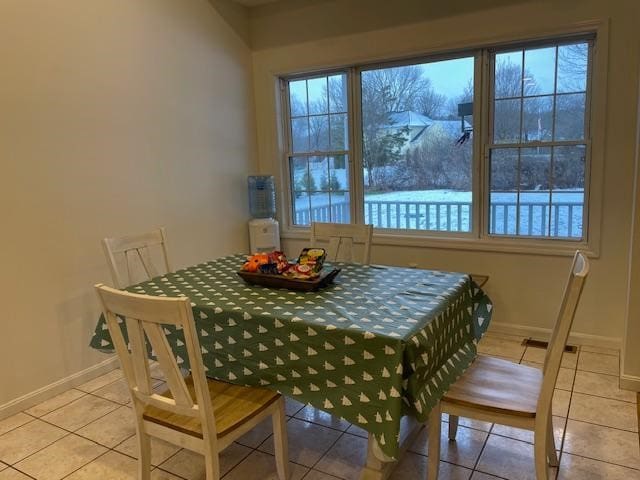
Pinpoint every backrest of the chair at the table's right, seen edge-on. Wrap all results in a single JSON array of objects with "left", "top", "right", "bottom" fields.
[{"left": 538, "top": 251, "right": 589, "bottom": 412}]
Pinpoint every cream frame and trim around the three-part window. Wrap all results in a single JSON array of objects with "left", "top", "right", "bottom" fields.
[{"left": 274, "top": 21, "right": 608, "bottom": 257}]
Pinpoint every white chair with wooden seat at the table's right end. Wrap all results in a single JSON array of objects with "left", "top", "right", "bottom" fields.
[{"left": 427, "top": 251, "right": 589, "bottom": 480}]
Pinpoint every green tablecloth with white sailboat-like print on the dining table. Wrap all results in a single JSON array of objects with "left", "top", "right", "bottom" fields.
[{"left": 91, "top": 255, "right": 492, "bottom": 457}]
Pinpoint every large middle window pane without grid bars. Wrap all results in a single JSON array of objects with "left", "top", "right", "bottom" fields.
[{"left": 360, "top": 56, "right": 475, "bottom": 232}]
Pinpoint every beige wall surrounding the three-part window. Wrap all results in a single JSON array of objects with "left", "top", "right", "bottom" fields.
[{"left": 251, "top": 0, "right": 640, "bottom": 346}]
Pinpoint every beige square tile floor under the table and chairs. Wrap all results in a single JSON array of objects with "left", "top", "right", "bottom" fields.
[{"left": 0, "top": 334, "right": 640, "bottom": 480}]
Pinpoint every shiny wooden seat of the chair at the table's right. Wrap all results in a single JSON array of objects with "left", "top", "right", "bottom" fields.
[{"left": 443, "top": 355, "right": 542, "bottom": 418}]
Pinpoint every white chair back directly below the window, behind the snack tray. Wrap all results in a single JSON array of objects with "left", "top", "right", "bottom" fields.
[{"left": 311, "top": 222, "right": 373, "bottom": 265}]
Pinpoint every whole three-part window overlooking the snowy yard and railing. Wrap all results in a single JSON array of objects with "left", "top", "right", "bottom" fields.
[{"left": 282, "top": 36, "right": 594, "bottom": 248}]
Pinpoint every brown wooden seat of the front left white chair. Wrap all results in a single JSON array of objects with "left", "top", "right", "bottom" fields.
[{"left": 142, "top": 375, "right": 280, "bottom": 438}]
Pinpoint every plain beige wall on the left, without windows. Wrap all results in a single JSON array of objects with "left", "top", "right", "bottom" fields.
[{"left": 0, "top": 0, "right": 256, "bottom": 406}]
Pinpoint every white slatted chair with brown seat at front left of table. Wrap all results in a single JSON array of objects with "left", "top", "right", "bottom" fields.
[{"left": 95, "top": 284, "right": 289, "bottom": 480}]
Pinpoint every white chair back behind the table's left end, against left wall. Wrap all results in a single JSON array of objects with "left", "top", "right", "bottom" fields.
[{"left": 102, "top": 227, "right": 172, "bottom": 288}]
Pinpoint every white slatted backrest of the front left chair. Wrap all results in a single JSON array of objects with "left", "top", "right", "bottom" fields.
[{"left": 96, "top": 285, "right": 215, "bottom": 426}]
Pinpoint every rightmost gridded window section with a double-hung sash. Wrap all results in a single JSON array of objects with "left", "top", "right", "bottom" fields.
[{"left": 488, "top": 41, "right": 589, "bottom": 239}]
